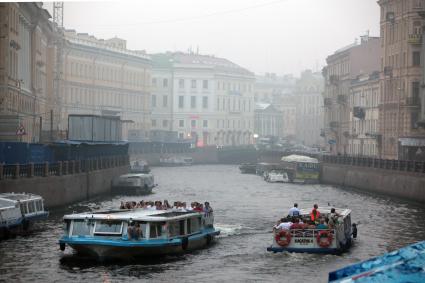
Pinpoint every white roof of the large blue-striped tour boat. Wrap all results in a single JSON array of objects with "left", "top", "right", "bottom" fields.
[{"left": 63, "top": 208, "right": 201, "bottom": 222}]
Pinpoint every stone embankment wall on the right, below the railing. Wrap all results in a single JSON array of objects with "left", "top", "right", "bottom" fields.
[{"left": 321, "top": 163, "right": 425, "bottom": 203}]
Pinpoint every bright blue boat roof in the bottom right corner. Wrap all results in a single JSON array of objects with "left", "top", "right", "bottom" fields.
[{"left": 329, "top": 241, "right": 425, "bottom": 283}]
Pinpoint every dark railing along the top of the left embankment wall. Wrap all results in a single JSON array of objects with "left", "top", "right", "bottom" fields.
[{"left": 0, "top": 155, "right": 129, "bottom": 180}]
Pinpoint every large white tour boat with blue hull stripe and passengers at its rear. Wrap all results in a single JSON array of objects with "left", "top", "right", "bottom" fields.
[{"left": 59, "top": 208, "right": 220, "bottom": 260}]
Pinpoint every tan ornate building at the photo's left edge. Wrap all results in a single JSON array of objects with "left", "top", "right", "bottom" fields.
[{"left": 0, "top": 2, "right": 56, "bottom": 142}]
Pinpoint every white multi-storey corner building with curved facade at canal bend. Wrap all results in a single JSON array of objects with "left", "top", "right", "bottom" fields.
[{"left": 151, "top": 52, "right": 255, "bottom": 146}]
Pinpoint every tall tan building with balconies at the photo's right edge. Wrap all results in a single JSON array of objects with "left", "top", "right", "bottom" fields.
[{"left": 378, "top": 0, "right": 425, "bottom": 160}]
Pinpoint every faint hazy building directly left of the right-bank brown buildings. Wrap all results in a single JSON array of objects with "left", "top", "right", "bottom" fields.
[{"left": 295, "top": 70, "right": 324, "bottom": 147}]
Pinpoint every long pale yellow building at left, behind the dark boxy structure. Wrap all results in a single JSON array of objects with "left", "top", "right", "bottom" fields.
[{"left": 59, "top": 30, "right": 152, "bottom": 139}]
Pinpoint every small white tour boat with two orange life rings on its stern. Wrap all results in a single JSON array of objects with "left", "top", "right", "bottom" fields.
[{"left": 267, "top": 207, "right": 357, "bottom": 254}]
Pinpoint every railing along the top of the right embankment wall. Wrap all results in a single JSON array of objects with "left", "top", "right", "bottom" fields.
[{"left": 321, "top": 155, "right": 425, "bottom": 173}]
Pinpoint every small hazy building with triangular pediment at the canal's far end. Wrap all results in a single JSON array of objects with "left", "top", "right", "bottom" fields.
[{"left": 254, "top": 102, "right": 283, "bottom": 137}]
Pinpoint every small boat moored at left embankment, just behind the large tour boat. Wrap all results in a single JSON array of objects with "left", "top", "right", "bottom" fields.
[{"left": 112, "top": 173, "right": 156, "bottom": 194}]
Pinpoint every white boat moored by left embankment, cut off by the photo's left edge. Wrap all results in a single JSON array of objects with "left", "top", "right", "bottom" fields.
[{"left": 0, "top": 193, "right": 49, "bottom": 239}]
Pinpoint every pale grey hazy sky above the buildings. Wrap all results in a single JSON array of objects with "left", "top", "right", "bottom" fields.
[{"left": 46, "top": 0, "right": 379, "bottom": 75}]
